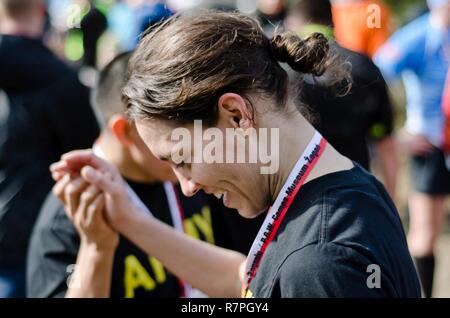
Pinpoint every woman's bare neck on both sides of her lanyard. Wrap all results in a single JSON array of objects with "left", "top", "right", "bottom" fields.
[{"left": 269, "top": 111, "right": 354, "bottom": 202}]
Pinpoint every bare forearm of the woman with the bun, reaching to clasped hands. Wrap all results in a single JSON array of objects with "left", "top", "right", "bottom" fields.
[{"left": 119, "top": 214, "right": 245, "bottom": 297}]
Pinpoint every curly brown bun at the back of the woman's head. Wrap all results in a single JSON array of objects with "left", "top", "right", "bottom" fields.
[{"left": 270, "top": 32, "right": 330, "bottom": 76}]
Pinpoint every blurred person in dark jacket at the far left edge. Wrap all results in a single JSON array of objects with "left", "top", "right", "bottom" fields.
[{"left": 0, "top": 0, "right": 99, "bottom": 297}]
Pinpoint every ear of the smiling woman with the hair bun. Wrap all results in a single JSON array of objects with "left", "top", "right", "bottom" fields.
[{"left": 218, "top": 93, "right": 254, "bottom": 130}]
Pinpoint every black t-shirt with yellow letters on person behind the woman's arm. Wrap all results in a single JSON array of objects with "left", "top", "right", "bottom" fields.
[{"left": 27, "top": 182, "right": 262, "bottom": 298}]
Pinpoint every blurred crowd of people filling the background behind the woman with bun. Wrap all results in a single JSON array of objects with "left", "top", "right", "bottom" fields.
[{"left": 0, "top": 0, "right": 450, "bottom": 297}]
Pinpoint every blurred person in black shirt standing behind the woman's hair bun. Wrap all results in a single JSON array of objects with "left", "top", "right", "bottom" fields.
[{"left": 286, "top": 0, "right": 398, "bottom": 198}]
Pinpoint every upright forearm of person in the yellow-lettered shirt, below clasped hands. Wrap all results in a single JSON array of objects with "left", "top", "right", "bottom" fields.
[{"left": 66, "top": 242, "right": 115, "bottom": 298}]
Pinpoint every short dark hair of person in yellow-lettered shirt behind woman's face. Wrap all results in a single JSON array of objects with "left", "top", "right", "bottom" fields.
[{"left": 93, "top": 52, "right": 131, "bottom": 128}]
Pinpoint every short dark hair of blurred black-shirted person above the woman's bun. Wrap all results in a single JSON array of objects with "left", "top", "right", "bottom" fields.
[{"left": 290, "top": 0, "right": 333, "bottom": 26}]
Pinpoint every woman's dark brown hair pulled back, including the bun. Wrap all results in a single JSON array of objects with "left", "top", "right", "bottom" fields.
[{"left": 123, "top": 11, "right": 348, "bottom": 124}]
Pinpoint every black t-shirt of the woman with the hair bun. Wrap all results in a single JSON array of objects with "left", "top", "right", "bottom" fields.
[{"left": 247, "top": 166, "right": 420, "bottom": 298}]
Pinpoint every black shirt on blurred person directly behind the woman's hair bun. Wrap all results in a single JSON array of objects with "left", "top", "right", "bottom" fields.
[{"left": 299, "top": 44, "right": 393, "bottom": 170}]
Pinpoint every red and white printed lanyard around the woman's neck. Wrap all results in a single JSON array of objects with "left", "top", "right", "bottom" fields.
[{"left": 243, "top": 131, "right": 327, "bottom": 297}]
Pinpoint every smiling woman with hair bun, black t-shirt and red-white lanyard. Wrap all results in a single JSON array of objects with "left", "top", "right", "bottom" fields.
[{"left": 51, "top": 11, "right": 420, "bottom": 297}]
